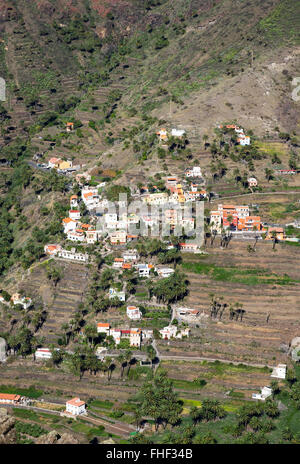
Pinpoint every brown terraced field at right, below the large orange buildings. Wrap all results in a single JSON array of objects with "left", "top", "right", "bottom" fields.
[{"left": 159, "top": 241, "right": 300, "bottom": 365}]
